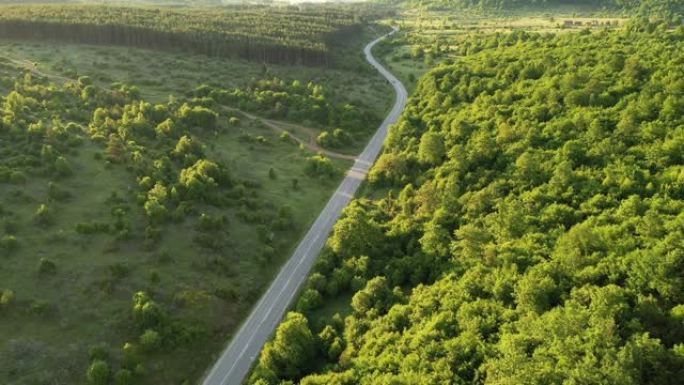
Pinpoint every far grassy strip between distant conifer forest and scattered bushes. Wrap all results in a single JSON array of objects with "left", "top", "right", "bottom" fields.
[{"left": 0, "top": 35, "right": 391, "bottom": 114}]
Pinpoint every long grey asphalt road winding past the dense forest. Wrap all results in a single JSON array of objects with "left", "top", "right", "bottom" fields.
[{"left": 202, "top": 29, "right": 407, "bottom": 385}]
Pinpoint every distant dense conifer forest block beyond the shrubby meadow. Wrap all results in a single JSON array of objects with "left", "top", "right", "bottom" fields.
[{"left": 0, "top": 5, "right": 390, "bottom": 65}]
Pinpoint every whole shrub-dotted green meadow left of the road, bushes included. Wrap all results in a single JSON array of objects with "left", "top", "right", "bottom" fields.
[{"left": 0, "top": 3, "right": 391, "bottom": 384}]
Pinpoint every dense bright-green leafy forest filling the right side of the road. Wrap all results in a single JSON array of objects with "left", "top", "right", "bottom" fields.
[{"left": 250, "top": 15, "right": 684, "bottom": 385}]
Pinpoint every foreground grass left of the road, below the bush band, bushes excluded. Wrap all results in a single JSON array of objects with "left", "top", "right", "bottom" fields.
[{"left": 0, "top": 108, "right": 351, "bottom": 384}]
